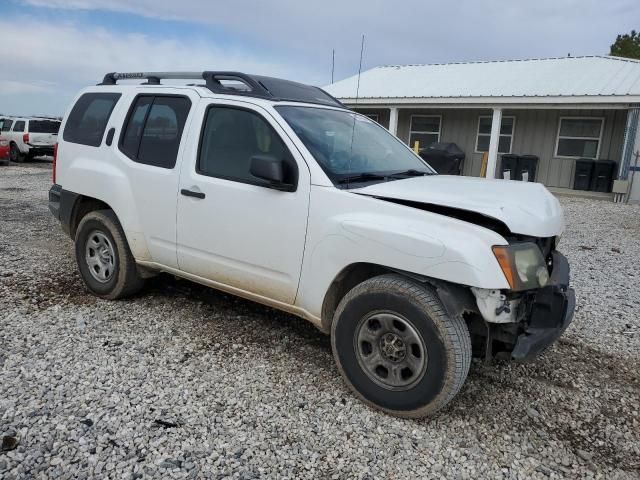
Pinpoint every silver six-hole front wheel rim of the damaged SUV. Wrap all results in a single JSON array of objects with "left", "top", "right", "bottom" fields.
[{"left": 354, "top": 312, "right": 428, "bottom": 390}]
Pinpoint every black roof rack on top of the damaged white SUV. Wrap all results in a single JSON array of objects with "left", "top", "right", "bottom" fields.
[{"left": 99, "top": 71, "right": 346, "bottom": 108}]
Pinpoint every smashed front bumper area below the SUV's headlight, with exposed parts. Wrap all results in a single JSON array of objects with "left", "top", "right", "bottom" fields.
[{"left": 469, "top": 250, "right": 575, "bottom": 362}]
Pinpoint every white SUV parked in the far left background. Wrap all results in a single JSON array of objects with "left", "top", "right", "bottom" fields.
[{"left": 2, "top": 117, "right": 60, "bottom": 162}]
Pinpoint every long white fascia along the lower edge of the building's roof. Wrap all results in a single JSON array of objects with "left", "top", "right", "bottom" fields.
[{"left": 339, "top": 95, "right": 640, "bottom": 109}]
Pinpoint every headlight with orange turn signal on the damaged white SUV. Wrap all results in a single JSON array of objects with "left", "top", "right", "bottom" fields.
[{"left": 493, "top": 243, "right": 549, "bottom": 291}]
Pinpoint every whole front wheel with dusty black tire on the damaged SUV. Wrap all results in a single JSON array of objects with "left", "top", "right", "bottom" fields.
[{"left": 331, "top": 274, "right": 471, "bottom": 418}]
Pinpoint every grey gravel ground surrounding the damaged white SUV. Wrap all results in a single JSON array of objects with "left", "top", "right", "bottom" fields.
[{"left": 0, "top": 163, "right": 640, "bottom": 480}]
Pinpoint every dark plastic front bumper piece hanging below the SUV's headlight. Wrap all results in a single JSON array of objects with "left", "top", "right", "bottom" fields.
[{"left": 511, "top": 252, "right": 576, "bottom": 362}]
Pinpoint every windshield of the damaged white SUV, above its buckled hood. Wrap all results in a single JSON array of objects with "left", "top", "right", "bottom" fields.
[{"left": 276, "top": 106, "right": 434, "bottom": 183}]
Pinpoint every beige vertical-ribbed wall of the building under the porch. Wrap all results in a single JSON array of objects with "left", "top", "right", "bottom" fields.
[{"left": 358, "top": 108, "right": 627, "bottom": 188}]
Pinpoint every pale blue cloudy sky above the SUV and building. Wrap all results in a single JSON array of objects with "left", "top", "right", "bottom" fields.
[{"left": 0, "top": 0, "right": 640, "bottom": 115}]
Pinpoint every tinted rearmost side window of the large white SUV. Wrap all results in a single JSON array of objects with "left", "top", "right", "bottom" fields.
[{"left": 62, "top": 93, "right": 120, "bottom": 147}]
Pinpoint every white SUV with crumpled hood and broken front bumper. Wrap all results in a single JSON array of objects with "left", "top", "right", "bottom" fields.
[{"left": 49, "top": 72, "right": 575, "bottom": 417}]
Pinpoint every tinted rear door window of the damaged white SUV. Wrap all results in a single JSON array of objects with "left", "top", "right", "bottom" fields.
[{"left": 120, "top": 95, "right": 191, "bottom": 168}]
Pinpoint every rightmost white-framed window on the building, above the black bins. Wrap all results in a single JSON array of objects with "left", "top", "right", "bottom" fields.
[{"left": 556, "top": 117, "right": 604, "bottom": 158}]
